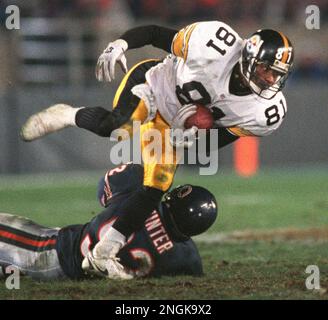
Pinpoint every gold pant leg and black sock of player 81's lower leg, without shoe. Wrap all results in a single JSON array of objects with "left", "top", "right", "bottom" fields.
[{"left": 113, "top": 114, "right": 179, "bottom": 237}]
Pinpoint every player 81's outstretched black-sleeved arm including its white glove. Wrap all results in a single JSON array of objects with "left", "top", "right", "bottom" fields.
[{"left": 96, "top": 25, "right": 177, "bottom": 82}]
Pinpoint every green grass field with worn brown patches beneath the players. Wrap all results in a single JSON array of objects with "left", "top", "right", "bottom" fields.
[{"left": 0, "top": 169, "right": 328, "bottom": 300}]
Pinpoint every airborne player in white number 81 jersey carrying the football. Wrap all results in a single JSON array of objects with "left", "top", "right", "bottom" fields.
[{"left": 21, "top": 21, "right": 294, "bottom": 278}]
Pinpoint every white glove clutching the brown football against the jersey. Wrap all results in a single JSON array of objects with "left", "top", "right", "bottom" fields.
[{"left": 170, "top": 104, "right": 198, "bottom": 148}]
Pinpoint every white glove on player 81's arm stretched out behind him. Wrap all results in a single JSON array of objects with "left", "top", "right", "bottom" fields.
[{"left": 96, "top": 39, "right": 128, "bottom": 82}]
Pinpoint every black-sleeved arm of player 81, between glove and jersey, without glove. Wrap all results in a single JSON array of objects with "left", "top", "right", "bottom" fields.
[{"left": 120, "top": 25, "right": 178, "bottom": 52}]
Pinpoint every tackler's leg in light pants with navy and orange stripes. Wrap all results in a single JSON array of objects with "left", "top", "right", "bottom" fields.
[{"left": 0, "top": 213, "right": 65, "bottom": 280}]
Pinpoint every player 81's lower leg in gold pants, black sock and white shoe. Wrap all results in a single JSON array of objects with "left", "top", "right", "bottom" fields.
[{"left": 84, "top": 114, "right": 179, "bottom": 279}]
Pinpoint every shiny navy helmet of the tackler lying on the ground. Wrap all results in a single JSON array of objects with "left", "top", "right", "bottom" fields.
[{"left": 162, "top": 184, "right": 218, "bottom": 241}]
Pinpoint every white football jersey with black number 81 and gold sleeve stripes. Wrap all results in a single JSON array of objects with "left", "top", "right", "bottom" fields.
[{"left": 146, "top": 21, "right": 287, "bottom": 136}]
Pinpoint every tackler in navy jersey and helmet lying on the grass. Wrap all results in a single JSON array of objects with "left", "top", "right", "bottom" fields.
[{"left": 0, "top": 164, "right": 217, "bottom": 280}]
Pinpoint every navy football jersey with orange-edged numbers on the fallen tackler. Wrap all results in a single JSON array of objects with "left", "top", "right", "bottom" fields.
[{"left": 57, "top": 164, "right": 203, "bottom": 279}]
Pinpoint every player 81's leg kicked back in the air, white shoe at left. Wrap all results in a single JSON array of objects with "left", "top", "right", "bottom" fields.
[{"left": 21, "top": 59, "right": 160, "bottom": 141}]
